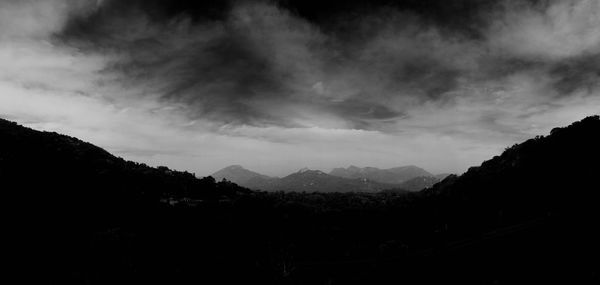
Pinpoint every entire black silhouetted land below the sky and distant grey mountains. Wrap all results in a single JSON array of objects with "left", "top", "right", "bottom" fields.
[{"left": 0, "top": 116, "right": 600, "bottom": 284}]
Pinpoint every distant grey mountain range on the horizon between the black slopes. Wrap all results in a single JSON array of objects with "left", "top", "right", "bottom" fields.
[{"left": 211, "top": 165, "right": 445, "bottom": 192}]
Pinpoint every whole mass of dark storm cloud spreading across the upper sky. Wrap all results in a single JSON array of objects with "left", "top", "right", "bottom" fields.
[{"left": 56, "top": 0, "right": 599, "bottom": 129}]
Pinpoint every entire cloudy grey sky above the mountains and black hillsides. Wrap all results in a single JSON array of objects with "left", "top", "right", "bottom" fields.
[{"left": 0, "top": 0, "right": 600, "bottom": 176}]
